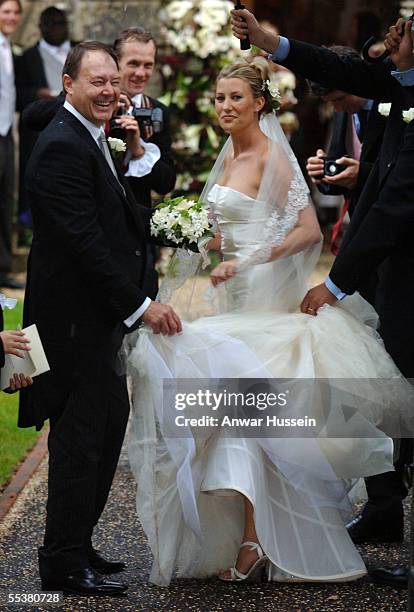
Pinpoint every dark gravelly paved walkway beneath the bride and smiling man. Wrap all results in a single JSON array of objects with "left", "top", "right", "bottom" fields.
[{"left": 0, "top": 442, "right": 408, "bottom": 612}]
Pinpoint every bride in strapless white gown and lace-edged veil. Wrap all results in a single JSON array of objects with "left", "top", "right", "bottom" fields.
[{"left": 129, "top": 58, "right": 410, "bottom": 585}]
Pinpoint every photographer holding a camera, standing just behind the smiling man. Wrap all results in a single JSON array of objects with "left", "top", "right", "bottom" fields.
[{"left": 109, "top": 28, "right": 176, "bottom": 298}]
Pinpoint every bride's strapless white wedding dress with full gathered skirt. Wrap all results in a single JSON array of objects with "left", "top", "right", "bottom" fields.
[{"left": 129, "top": 184, "right": 408, "bottom": 585}]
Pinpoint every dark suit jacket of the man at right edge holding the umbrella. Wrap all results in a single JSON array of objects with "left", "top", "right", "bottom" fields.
[{"left": 283, "top": 41, "right": 414, "bottom": 377}]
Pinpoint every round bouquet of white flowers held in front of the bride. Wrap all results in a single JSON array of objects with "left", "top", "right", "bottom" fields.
[{"left": 150, "top": 196, "right": 214, "bottom": 252}]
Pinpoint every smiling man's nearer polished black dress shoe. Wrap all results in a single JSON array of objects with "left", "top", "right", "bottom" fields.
[{"left": 42, "top": 567, "right": 128, "bottom": 595}]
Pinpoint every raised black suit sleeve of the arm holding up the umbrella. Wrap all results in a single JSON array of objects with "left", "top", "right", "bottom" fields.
[{"left": 280, "top": 40, "right": 401, "bottom": 101}]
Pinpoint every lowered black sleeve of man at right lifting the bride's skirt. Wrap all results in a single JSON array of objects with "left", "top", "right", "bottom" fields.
[{"left": 329, "top": 123, "right": 414, "bottom": 294}]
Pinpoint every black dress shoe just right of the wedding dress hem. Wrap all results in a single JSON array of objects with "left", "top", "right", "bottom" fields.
[{"left": 346, "top": 514, "right": 404, "bottom": 544}]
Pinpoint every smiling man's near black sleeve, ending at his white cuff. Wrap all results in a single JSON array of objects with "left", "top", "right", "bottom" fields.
[{"left": 29, "top": 139, "right": 146, "bottom": 321}]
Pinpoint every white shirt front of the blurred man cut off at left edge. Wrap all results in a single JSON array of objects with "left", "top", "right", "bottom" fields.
[{"left": 0, "top": 32, "right": 16, "bottom": 136}]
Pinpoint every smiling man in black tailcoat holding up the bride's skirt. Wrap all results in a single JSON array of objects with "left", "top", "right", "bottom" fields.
[{"left": 19, "top": 42, "right": 181, "bottom": 595}]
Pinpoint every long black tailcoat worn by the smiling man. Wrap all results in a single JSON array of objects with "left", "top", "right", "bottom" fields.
[{"left": 19, "top": 108, "right": 149, "bottom": 427}]
